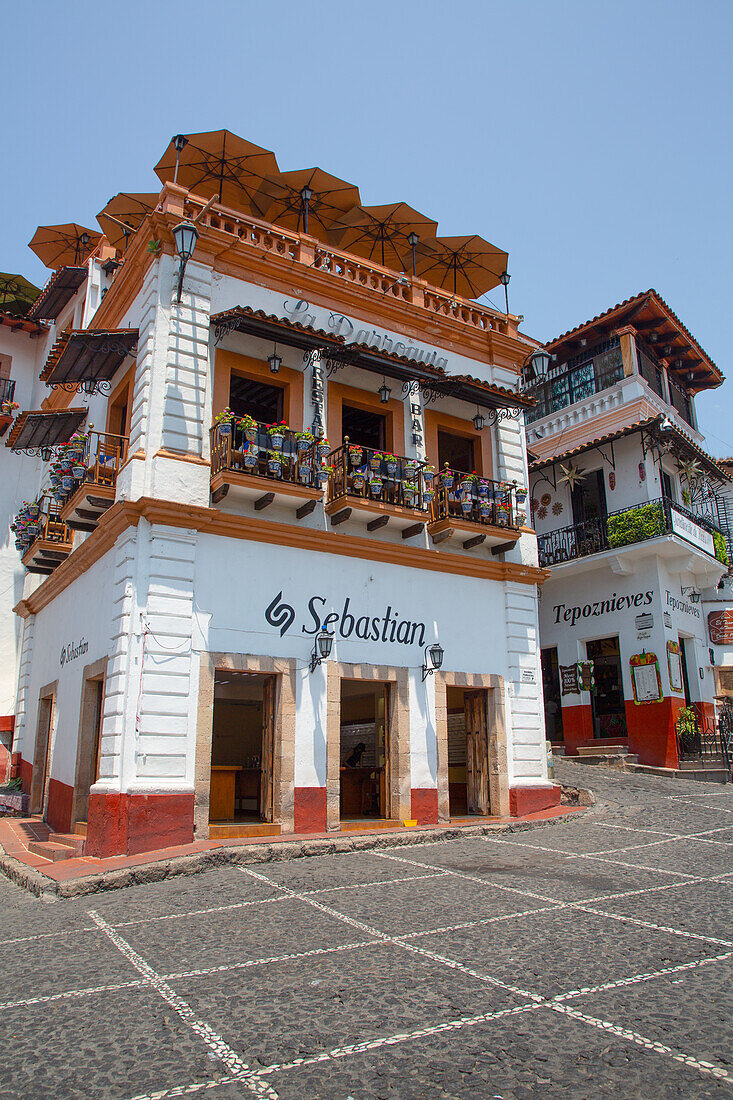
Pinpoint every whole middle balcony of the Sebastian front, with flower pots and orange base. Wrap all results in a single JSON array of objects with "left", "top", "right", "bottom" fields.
[{"left": 326, "top": 439, "right": 435, "bottom": 539}]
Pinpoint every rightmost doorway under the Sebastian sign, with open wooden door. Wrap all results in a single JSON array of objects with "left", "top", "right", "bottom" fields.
[{"left": 446, "top": 686, "right": 491, "bottom": 817}]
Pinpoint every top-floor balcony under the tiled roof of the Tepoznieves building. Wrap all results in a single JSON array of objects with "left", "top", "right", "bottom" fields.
[{"left": 526, "top": 337, "right": 624, "bottom": 424}]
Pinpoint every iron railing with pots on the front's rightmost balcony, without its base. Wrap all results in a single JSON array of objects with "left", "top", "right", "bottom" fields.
[{"left": 430, "top": 464, "right": 526, "bottom": 529}]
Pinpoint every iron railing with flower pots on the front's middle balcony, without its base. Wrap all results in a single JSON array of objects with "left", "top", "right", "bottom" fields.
[{"left": 328, "top": 438, "right": 435, "bottom": 512}]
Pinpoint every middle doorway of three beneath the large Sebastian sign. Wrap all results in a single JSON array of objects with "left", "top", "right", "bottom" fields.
[{"left": 339, "top": 680, "right": 390, "bottom": 821}]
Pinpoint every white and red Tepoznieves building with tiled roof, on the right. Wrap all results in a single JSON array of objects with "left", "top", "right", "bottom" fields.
[{"left": 525, "top": 290, "right": 730, "bottom": 768}]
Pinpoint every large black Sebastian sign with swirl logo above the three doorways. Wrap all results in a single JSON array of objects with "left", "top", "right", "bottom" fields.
[{"left": 264, "top": 591, "right": 425, "bottom": 647}]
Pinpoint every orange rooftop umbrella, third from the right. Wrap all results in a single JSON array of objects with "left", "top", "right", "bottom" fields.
[{"left": 256, "top": 168, "right": 360, "bottom": 240}]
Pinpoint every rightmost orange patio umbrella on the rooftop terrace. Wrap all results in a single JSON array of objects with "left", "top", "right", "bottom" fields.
[{"left": 417, "top": 237, "right": 508, "bottom": 298}]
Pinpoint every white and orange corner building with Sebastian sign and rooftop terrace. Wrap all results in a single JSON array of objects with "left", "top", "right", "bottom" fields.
[{"left": 6, "top": 135, "right": 559, "bottom": 855}]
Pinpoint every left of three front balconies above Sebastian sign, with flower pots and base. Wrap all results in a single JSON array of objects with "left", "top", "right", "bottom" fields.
[{"left": 210, "top": 418, "right": 328, "bottom": 519}]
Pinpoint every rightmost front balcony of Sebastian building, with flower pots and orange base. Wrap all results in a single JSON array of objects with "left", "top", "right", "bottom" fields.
[{"left": 428, "top": 465, "right": 527, "bottom": 553}]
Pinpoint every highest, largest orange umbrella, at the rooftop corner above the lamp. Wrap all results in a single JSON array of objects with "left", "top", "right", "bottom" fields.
[{"left": 155, "top": 130, "right": 278, "bottom": 217}]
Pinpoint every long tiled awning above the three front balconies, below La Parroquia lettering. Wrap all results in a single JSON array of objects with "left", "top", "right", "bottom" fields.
[{"left": 211, "top": 306, "right": 535, "bottom": 419}]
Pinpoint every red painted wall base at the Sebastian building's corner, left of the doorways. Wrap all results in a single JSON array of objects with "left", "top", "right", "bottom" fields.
[{"left": 84, "top": 791, "right": 194, "bottom": 858}]
